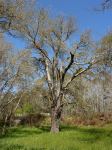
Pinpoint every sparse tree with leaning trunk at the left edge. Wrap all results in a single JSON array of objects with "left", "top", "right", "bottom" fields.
[{"left": 0, "top": 33, "right": 35, "bottom": 133}]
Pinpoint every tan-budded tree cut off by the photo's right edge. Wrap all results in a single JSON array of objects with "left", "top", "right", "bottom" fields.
[{"left": 97, "top": 32, "right": 112, "bottom": 113}]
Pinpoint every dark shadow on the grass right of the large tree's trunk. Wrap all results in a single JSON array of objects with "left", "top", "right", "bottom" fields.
[{"left": 62, "top": 126, "right": 112, "bottom": 143}]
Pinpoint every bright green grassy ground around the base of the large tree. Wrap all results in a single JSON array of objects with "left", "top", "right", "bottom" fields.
[{"left": 0, "top": 125, "right": 112, "bottom": 150}]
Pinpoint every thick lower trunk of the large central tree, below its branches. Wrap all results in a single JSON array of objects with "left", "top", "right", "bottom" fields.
[{"left": 51, "top": 106, "right": 62, "bottom": 133}]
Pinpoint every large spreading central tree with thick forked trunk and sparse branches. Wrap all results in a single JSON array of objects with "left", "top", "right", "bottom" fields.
[{"left": 0, "top": 0, "right": 96, "bottom": 133}]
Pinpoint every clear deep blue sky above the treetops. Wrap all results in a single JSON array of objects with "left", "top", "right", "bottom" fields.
[{"left": 6, "top": 0, "right": 112, "bottom": 48}]
